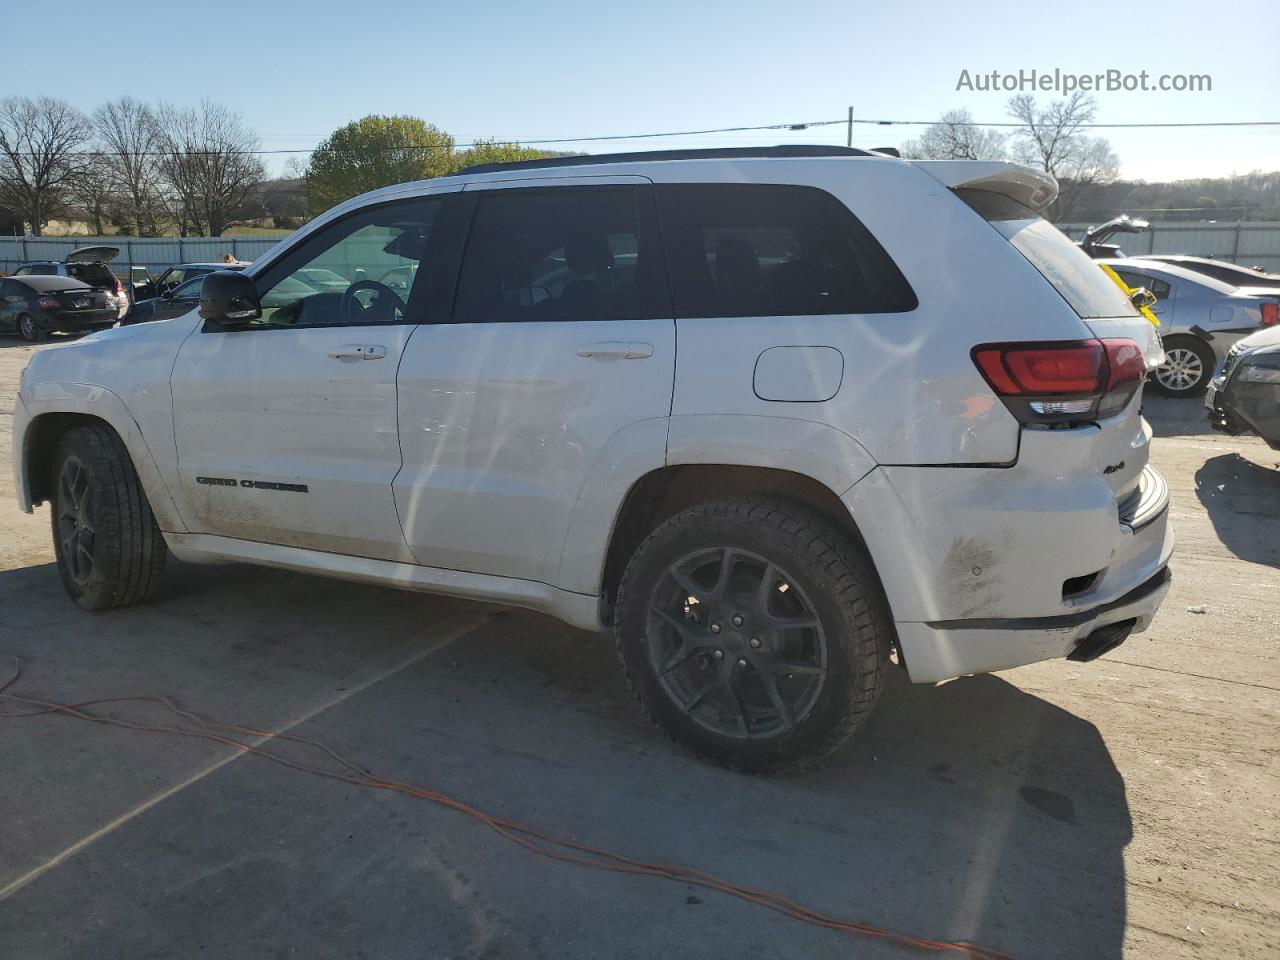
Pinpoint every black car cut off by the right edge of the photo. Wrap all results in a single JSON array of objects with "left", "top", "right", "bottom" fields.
[{"left": 1204, "top": 326, "right": 1280, "bottom": 451}]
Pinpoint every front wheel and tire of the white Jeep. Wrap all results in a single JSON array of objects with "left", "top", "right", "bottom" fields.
[{"left": 50, "top": 426, "right": 168, "bottom": 611}]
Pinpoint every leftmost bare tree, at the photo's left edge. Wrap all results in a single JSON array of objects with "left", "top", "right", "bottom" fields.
[{"left": 0, "top": 97, "right": 91, "bottom": 237}]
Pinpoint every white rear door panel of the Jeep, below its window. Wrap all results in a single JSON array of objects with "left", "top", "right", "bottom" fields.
[{"left": 396, "top": 319, "right": 676, "bottom": 594}]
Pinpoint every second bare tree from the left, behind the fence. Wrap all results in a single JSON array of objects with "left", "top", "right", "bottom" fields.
[{"left": 93, "top": 97, "right": 160, "bottom": 237}]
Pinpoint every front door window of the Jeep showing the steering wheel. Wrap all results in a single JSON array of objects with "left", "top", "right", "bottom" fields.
[{"left": 252, "top": 197, "right": 444, "bottom": 326}]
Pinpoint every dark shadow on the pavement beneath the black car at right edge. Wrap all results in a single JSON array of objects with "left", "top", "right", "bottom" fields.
[{"left": 1196, "top": 453, "right": 1280, "bottom": 567}]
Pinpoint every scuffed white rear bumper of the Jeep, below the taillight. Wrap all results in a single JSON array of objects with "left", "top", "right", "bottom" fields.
[{"left": 844, "top": 431, "right": 1174, "bottom": 682}]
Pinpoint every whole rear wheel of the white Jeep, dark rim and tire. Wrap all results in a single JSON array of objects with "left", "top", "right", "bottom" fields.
[{"left": 614, "top": 499, "right": 892, "bottom": 773}]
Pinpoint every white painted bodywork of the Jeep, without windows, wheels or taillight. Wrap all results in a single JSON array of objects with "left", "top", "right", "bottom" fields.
[{"left": 14, "top": 157, "right": 1172, "bottom": 681}]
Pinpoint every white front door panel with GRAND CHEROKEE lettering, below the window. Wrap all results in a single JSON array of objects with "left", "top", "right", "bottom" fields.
[{"left": 173, "top": 324, "right": 417, "bottom": 561}]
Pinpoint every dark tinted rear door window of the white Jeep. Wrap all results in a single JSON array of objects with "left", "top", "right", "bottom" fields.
[{"left": 453, "top": 187, "right": 671, "bottom": 323}]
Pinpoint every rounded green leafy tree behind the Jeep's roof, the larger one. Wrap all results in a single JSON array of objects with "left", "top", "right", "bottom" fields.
[{"left": 306, "top": 115, "right": 454, "bottom": 216}]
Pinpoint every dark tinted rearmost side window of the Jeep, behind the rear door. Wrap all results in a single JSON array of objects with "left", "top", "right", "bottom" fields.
[{"left": 658, "top": 183, "right": 916, "bottom": 316}]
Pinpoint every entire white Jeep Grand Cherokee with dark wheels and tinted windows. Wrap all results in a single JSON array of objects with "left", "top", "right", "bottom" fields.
[{"left": 14, "top": 147, "right": 1172, "bottom": 771}]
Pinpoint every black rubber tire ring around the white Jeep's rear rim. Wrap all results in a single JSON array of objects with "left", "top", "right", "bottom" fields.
[{"left": 614, "top": 513, "right": 875, "bottom": 771}]
